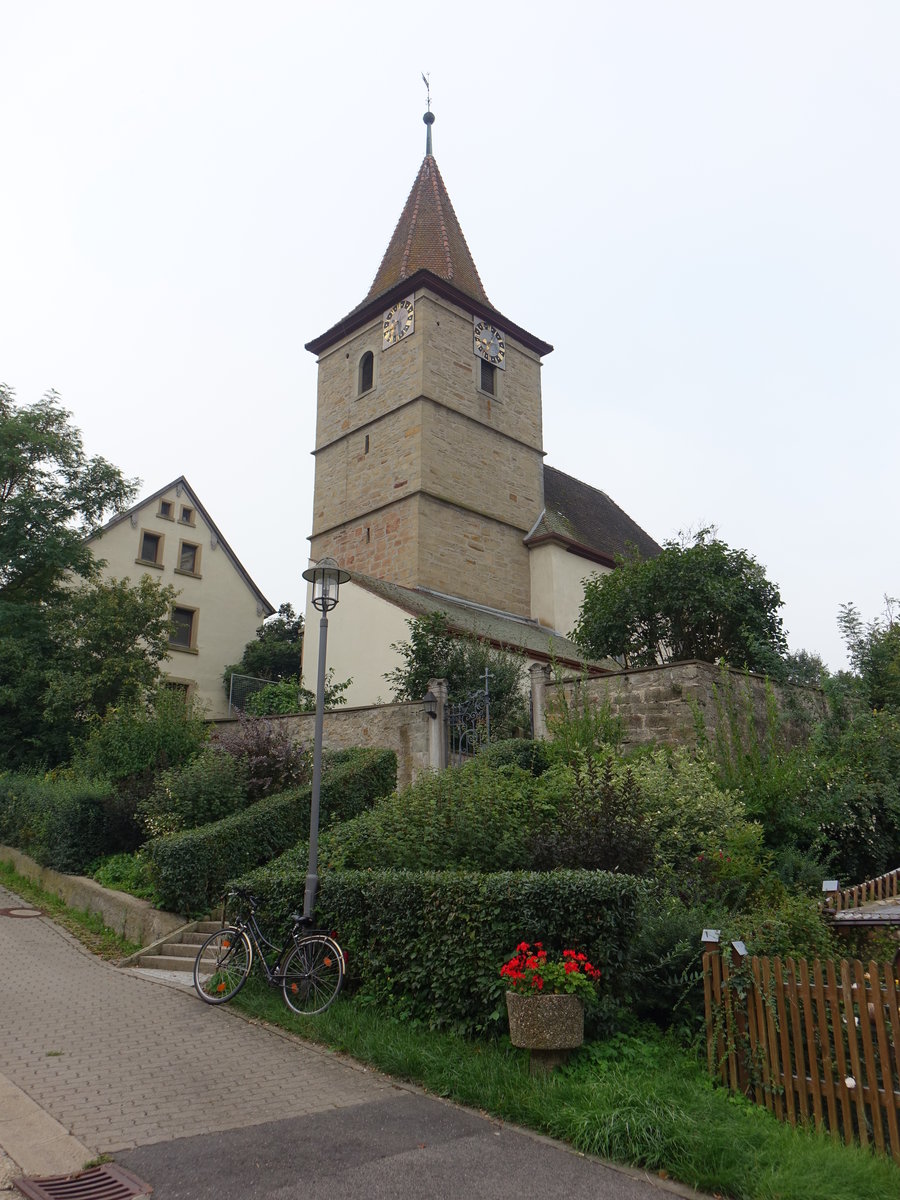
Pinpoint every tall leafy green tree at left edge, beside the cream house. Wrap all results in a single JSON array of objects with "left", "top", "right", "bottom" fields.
[{"left": 0, "top": 385, "right": 160, "bottom": 767}]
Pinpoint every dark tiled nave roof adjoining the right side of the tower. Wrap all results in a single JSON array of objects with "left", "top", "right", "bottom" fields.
[{"left": 526, "top": 466, "right": 662, "bottom": 565}]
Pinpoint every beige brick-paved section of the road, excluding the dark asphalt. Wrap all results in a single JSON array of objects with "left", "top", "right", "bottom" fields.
[{"left": 0, "top": 888, "right": 391, "bottom": 1154}]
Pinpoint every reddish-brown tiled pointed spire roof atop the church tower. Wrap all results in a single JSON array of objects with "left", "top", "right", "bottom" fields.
[{"left": 364, "top": 154, "right": 491, "bottom": 306}]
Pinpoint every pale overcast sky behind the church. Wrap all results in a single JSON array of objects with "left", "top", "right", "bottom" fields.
[{"left": 0, "top": 0, "right": 900, "bottom": 667}]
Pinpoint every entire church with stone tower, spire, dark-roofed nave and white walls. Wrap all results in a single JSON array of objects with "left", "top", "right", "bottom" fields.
[{"left": 304, "top": 113, "right": 660, "bottom": 704}]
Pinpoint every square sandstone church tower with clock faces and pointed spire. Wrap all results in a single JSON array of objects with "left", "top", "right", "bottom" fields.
[{"left": 306, "top": 112, "right": 552, "bottom": 618}]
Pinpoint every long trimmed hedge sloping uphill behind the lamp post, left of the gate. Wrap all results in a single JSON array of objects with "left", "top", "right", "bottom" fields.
[{"left": 145, "top": 749, "right": 397, "bottom": 914}]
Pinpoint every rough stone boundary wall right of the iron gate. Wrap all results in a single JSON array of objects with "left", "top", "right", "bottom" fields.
[{"left": 532, "top": 660, "right": 826, "bottom": 745}]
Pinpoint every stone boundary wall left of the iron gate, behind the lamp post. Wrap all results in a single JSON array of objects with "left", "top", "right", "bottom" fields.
[{"left": 211, "top": 701, "right": 434, "bottom": 787}]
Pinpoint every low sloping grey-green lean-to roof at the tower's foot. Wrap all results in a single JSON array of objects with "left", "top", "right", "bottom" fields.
[{"left": 350, "top": 571, "right": 620, "bottom": 672}]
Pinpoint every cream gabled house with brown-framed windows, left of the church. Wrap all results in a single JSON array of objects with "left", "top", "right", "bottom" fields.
[{"left": 89, "top": 475, "right": 275, "bottom": 716}]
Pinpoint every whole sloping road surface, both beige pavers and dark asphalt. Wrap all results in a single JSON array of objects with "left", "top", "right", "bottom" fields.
[{"left": 0, "top": 887, "right": 710, "bottom": 1200}]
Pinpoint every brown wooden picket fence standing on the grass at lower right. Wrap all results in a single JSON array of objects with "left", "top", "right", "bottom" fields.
[{"left": 703, "top": 942, "right": 900, "bottom": 1163}]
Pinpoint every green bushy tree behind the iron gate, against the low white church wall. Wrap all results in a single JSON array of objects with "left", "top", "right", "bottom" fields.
[{"left": 384, "top": 612, "right": 528, "bottom": 738}]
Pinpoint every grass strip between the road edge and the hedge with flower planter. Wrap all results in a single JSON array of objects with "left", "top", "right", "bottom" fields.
[{"left": 233, "top": 978, "right": 900, "bottom": 1200}]
